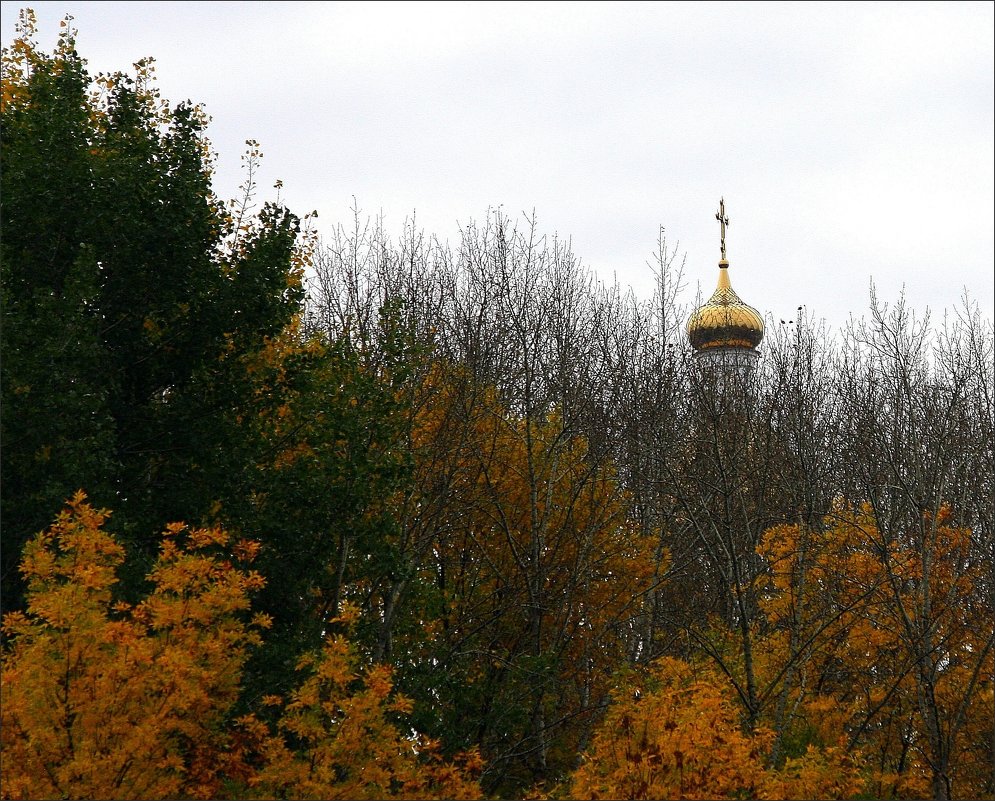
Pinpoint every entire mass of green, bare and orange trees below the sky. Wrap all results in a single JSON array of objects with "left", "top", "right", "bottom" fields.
[{"left": 0, "top": 11, "right": 995, "bottom": 799}]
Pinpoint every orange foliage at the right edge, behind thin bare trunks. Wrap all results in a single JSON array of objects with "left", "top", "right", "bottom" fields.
[{"left": 758, "top": 504, "right": 993, "bottom": 797}]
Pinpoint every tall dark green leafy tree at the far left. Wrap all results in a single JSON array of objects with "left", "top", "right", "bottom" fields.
[{"left": 0, "top": 18, "right": 303, "bottom": 609}]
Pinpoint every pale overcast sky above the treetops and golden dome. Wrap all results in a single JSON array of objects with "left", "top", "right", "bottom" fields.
[{"left": 2, "top": 2, "right": 995, "bottom": 329}]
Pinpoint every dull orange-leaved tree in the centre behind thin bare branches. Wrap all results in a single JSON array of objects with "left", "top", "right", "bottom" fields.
[{"left": 412, "top": 364, "right": 663, "bottom": 781}]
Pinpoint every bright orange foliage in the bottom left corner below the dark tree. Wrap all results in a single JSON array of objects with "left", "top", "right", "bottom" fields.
[{"left": 0, "top": 493, "right": 266, "bottom": 798}]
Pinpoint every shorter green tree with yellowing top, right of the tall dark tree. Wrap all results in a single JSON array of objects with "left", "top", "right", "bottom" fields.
[{"left": 221, "top": 324, "right": 411, "bottom": 694}]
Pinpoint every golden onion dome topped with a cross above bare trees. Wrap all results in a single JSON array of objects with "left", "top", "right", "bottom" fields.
[{"left": 688, "top": 199, "right": 764, "bottom": 375}]
